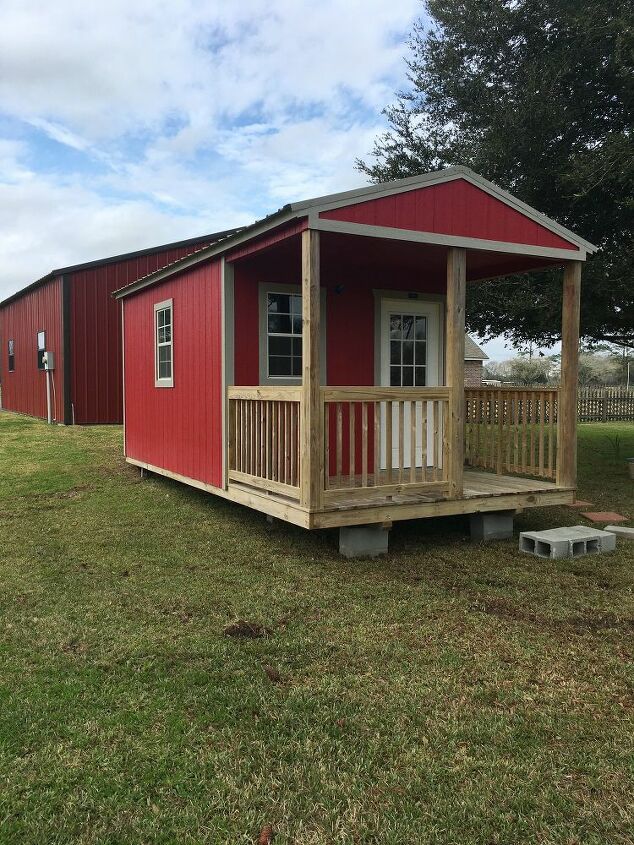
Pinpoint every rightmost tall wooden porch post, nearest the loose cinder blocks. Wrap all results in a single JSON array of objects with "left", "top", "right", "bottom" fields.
[{"left": 557, "top": 261, "right": 581, "bottom": 487}]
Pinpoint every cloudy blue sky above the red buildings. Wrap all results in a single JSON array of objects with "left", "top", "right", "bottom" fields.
[{"left": 0, "top": 0, "right": 520, "bottom": 357}]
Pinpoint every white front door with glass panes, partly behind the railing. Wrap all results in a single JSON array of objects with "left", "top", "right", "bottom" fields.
[{"left": 381, "top": 299, "right": 442, "bottom": 468}]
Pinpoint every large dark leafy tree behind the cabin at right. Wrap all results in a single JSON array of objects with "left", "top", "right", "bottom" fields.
[{"left": 357, "top": 0, "right": 634, "bottom": 346}]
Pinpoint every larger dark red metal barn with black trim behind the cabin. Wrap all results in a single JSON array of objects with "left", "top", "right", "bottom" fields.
[{"left": 0, "top": 230, "right": 235, "bottom": 424}]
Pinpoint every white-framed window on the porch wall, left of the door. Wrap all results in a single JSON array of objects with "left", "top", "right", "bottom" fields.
[{"left": 266, "top": 291, "right": 302, "bottom": 378}]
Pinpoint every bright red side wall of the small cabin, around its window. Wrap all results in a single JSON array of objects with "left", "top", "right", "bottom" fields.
[{"left": 123, "top": 261, "right": 222, "bottom": 487}]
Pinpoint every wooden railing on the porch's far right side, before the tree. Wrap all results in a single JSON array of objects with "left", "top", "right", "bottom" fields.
[{"left": 465, "top": 387, "right": 558, "bottom": 478}]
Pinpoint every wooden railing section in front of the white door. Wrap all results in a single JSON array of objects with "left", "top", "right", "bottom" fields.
[{"left": 321, "top": 387, "right": 450, "bottom": 504}]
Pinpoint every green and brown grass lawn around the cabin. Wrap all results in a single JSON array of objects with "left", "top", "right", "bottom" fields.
[{"left": 0, "top": 414, "right": 634, "bottom": 845}]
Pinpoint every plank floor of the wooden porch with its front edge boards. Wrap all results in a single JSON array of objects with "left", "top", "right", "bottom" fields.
[{"left": 227, "top": 468, "right": 574, "bottom": 528}]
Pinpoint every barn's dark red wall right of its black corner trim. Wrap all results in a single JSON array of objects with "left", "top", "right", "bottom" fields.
[{"left": 71, "top": 244, "right": 210, "bottom": 424}]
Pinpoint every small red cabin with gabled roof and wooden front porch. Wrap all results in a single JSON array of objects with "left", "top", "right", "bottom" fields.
[{"left": 116, "top": 167, "right": 594, "bottom": 544}]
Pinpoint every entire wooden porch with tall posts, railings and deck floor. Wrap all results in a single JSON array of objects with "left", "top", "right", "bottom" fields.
[{"left": 225, "top": 229, "right": 580, "bottom": 528}]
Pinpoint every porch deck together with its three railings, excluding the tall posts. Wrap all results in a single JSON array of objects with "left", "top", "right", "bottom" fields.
[{"left": 228, "top": 387, "right": 574, "bottom": 528}]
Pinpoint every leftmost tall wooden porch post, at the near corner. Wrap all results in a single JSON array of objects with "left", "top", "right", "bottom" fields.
[{"left": 300, "top": 229, "right": 323, "bottom": 510}]
